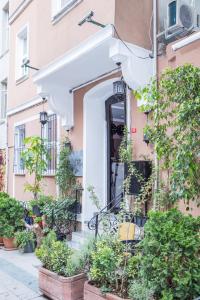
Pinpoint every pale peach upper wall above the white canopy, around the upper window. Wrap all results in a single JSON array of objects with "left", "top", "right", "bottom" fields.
[{"left": 8, "top": 0, "right": 115, "bottom": 109}]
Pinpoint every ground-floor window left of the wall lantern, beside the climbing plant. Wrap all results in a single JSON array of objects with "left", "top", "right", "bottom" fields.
[{"left": 14, "top": 124, "right": 25, "bottom": 174}]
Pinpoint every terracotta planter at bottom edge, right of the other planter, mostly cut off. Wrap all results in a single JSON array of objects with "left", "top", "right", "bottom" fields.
[{"left": 84, "top": 281, "right": 128, "bottom": 300}]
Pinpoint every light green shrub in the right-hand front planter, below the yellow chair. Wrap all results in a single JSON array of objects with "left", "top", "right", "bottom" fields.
[{"left": 84, "top": 235, "right": 133, "bottom": 300}]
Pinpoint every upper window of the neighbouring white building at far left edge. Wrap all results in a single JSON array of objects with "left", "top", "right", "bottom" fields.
[{"left": 1, "top": 3, "right": 9, "bottom": 54}]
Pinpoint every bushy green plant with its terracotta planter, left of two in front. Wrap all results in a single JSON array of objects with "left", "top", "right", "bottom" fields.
[{"left": 36, "top": 231, "right": 86, "bottom": 300}]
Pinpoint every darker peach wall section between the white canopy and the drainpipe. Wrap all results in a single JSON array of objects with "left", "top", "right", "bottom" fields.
[{"left": 115, "top": 0, "right": 153, "bottom": 49}]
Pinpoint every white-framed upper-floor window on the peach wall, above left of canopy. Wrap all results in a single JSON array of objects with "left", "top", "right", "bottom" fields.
[{"left": 16, "top": 25, "right": 29, "bottom": 79}]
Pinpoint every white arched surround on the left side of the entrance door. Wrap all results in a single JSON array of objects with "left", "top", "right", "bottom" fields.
[{"left": 82, "top": 78, "right": 119, "bottom": 223}]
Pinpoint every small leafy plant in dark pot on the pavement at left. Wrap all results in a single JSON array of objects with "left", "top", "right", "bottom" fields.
[{"left": 15, "top": 230, "right": 35, "bottom": 253}]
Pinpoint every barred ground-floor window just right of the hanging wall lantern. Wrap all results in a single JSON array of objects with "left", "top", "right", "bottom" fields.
[{"left": 42, "top": 114, "right": 57, "bottom": 175}]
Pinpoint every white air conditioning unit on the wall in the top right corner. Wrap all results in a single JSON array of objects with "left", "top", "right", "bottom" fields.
[{"left": 165, "top": 0, "right": 200, "bottom": 40}]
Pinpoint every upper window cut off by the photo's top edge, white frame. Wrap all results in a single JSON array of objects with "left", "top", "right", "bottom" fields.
[{"left": 52, "top": 0, "right": 82, "bottom": 21}]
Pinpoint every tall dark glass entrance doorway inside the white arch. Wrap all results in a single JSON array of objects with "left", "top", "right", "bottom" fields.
[{"left": 106, "top": 95, "right": 126, "bottom": 207}]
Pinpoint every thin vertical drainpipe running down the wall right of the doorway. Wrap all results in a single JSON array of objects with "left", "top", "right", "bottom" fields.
[{"left": 153, "top": 0, "right": 160, "bottom": 210}]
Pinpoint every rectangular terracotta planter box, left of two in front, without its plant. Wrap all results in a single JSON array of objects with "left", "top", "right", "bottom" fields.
[{"left": 39, "top": 268, "right": 86, "bottom": 300}]
